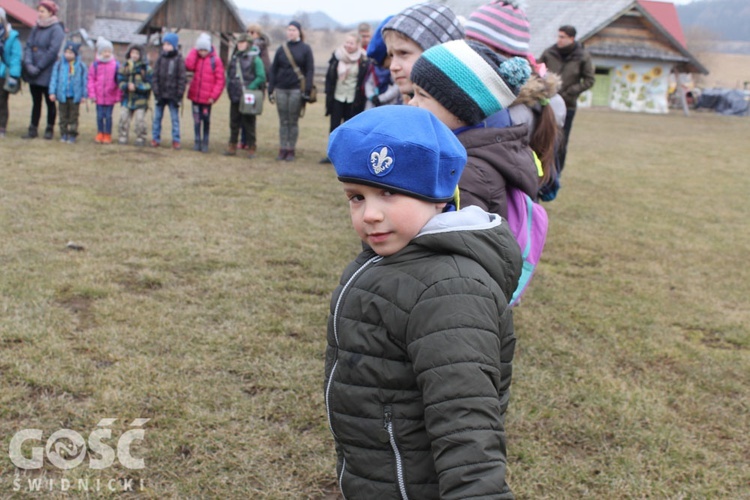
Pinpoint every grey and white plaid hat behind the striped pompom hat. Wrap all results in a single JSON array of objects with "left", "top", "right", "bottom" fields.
[{"left": 382, "top": 3, "right": 464, "bottom": 50}]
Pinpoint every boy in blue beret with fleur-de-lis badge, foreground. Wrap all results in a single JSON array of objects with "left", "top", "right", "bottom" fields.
[{"left": 325, "top": 106, "right": 521, "bottom": 499}]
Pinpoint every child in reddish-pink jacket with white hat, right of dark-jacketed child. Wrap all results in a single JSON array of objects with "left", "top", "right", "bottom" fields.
[{"left": 185, "top": 33, "right": 224, "bottom": 153}]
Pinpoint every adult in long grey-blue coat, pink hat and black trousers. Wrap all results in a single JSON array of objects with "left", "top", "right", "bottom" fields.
[{"left": 23, "top": 0, "right": 65, "bottom": 139}]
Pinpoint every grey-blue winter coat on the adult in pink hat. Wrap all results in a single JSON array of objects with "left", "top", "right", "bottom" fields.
[{"left": 23, "top": 22, "right": 65, "bottom": 87}]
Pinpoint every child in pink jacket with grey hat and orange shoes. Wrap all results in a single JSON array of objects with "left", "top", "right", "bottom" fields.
[{"left": 87, "top": 37, "right": 121, "bottom": 144}]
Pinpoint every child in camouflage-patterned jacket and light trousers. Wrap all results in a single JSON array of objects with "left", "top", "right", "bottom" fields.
[{"left": 117, "top": 45, "right": 153, "bottom": 146}]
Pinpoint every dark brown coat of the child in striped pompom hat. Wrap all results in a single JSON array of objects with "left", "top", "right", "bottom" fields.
[{"left": 457, "top": 125, "right": 539, "bottom": 217}]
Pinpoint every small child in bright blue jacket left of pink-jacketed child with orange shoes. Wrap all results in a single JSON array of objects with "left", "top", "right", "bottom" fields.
[{"left": 49, "top": 42, "right": 88, "bottom": 144}]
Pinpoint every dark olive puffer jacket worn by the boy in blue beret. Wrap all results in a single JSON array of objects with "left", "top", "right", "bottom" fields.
[{"left": 325, "top": 207, "right": 522, "bottom": 500}]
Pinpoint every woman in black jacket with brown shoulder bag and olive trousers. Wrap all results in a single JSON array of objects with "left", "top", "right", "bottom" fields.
[{"left": 268, "top": 21, "right": 315, "bottom": 161}]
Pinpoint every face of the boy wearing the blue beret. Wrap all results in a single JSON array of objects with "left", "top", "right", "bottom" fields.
[{"left": 344, "top": 182, "right": 446, "bottom": 257}]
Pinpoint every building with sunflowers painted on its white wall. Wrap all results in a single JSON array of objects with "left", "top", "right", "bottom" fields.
[{"left": 526, "top": 0, "right": 708, "bottom": 113}]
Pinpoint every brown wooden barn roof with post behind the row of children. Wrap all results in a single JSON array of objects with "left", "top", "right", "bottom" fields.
[{"left": 138, "top": 0, "right": 245, "bottom": 62}]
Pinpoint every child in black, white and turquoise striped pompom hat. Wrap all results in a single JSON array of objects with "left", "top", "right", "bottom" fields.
[{"left": 409, "top": 40, "right": 540, "bottom": 217}]
